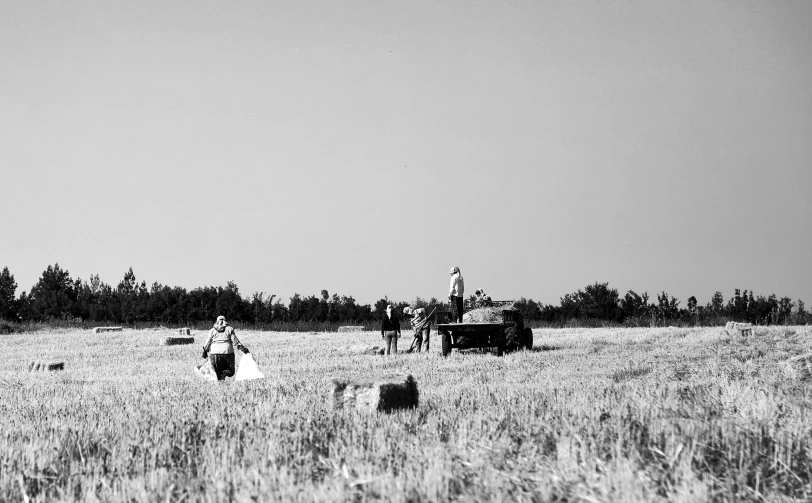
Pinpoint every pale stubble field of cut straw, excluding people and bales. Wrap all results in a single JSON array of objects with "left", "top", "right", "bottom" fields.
[{"left": 0, "top": 327, "right": 812, "bottom": 502}]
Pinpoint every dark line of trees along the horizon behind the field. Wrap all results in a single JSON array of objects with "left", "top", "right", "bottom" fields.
[{"left": 0, "top": 263, "right": 812, "bottom": 329}]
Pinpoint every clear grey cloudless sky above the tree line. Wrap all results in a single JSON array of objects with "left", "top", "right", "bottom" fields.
[{"left": 0, "top": 0, "right": 812, "bottom": 306}]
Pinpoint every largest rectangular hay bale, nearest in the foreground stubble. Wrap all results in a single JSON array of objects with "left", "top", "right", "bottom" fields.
[{"left": 333, "top": 374, "right": 419, "bottom": 412}]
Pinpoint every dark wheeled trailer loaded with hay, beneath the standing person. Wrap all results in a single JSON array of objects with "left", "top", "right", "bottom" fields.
[{"left": 436, "top": 301, "right": 533, "bottom": 356}]
